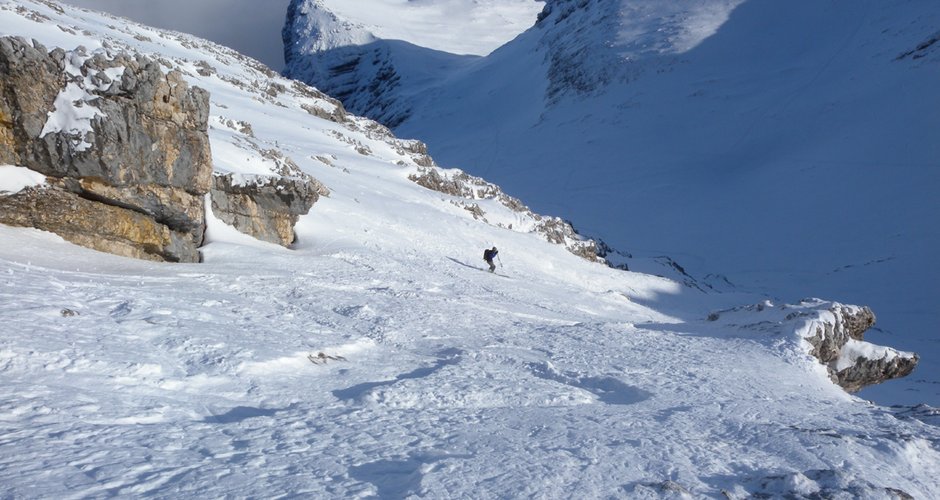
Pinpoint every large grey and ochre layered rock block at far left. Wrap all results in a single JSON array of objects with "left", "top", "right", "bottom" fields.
[{"left": 0, "top": 38, "right": 212, "bottom": 262}]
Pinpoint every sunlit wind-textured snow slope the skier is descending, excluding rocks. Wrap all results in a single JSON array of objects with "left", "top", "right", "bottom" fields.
[{"left": 0, "top": 0, "right": 940, "bottom": 498}]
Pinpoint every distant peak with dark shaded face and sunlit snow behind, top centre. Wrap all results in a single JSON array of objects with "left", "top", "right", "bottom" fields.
[{"left": 283, "top": 0, "right": 541, "bottom": 126}]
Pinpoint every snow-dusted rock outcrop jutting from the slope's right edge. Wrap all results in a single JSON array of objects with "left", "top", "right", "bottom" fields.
[{"left": 708, "top": 299, "right": 919, "bottom": 392}]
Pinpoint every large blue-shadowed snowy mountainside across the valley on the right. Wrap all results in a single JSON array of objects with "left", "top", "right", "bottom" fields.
[{"left": 298, "top": 0, "right": 940, "bottom": 404}]
